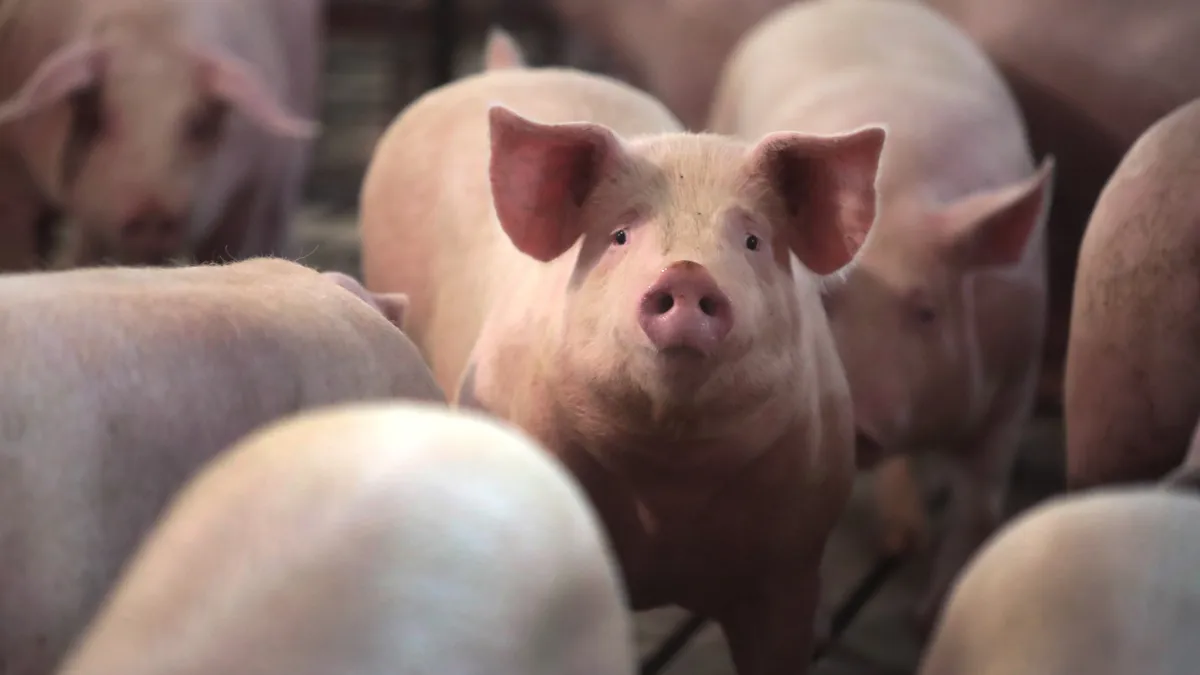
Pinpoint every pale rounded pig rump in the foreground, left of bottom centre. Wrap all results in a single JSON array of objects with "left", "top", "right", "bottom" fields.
[{"left": 58, "top": 402, "right": 635, "bottom": 675}]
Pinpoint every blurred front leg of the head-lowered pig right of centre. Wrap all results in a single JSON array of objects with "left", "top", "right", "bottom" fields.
[{"left": 917, "top": 396, "right": 1034, "bottom": 633}]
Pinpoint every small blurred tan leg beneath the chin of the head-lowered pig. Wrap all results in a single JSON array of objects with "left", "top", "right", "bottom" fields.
[{"left": 872, "top": 455, "right": 929, "bottom": 555}]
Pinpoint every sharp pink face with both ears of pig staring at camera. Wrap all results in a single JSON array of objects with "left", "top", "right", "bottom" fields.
[{"left": 490, "top": 106, "right": 886, "bottom": 406}]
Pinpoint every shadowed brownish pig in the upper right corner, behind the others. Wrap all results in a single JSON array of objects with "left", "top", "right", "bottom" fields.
[{"left": 928, "top": 0, "right": 1200, "bottom": 406}]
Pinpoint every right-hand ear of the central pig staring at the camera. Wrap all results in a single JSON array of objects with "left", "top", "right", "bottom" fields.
[{"left": 750, "top": 126, "right": 887, "bottom": 274}]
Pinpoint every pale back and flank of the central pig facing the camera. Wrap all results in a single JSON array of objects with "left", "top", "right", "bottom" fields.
[{"left": 361, "top": 68, "right": 679, "bottom": 392}]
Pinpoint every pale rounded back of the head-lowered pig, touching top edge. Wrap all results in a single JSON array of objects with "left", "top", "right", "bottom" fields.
[{"left": 710, "top": 0, "right": 1008, "bottom": 136}]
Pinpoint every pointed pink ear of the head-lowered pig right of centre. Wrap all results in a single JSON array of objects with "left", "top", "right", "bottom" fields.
[{"left": 943, "top": 156, "right": 1055, "bottom": 268}]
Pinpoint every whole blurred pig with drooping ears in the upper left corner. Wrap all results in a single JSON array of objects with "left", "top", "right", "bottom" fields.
[{"left": 0, "top": 0, "right": 323, "bottom": 270}]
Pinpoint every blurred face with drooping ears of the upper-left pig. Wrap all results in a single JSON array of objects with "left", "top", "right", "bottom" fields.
[{"left": 0, "top": 22, "right": 314, "bottom": 263}]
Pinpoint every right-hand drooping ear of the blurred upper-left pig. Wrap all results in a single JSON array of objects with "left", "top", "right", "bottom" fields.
[{"left": 194, "top": 49, "right": 320, "bottom": 138}]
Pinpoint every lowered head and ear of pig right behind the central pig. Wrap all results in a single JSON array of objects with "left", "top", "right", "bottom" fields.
[{"left": 822, "top": 159, "right": 1054, "bottom": 451}]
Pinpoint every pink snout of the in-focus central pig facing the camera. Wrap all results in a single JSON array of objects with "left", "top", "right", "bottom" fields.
[{"left": 637, "top": 261, "right": 733, "bottom": 356}]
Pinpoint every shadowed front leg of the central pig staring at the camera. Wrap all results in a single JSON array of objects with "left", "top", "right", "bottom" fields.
[{"left": 716, "top": 557, "right": 823, "bottom": 675}]
